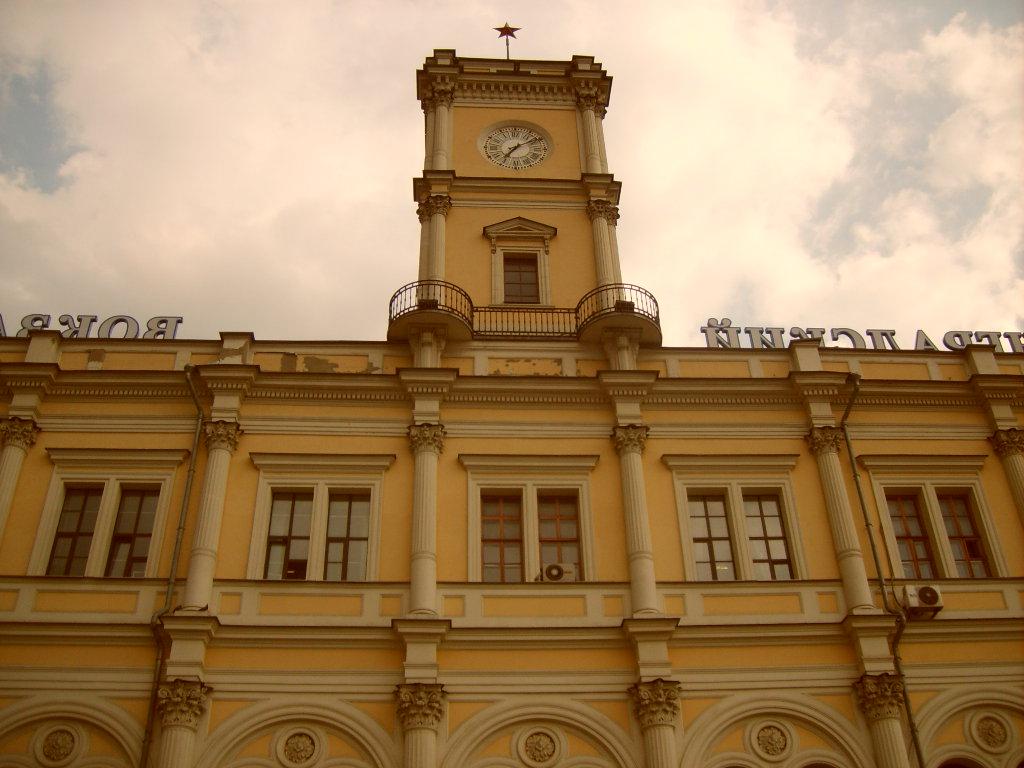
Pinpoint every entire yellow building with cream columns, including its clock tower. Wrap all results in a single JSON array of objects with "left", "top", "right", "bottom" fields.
[{"left": 0, "top": 50, "right": 1024, "bottom": 768}]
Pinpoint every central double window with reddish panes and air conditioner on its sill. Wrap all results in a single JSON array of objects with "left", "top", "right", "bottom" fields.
[{"left": 459, "top": 454, "right": 597, "bottom": 584}]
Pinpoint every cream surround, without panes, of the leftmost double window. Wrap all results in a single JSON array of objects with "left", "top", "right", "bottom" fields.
[{"left": 29, "top": 447, "right": 188, "bottom": 579}]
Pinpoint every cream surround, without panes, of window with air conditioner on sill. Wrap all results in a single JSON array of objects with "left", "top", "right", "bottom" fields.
[{"left": 459, "top": 454, "right": 598, "bottom": 586}]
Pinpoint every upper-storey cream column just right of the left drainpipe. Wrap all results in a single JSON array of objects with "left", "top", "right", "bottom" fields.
[{"left": 182, "top": 421, "right": 242, "bottom": 609}]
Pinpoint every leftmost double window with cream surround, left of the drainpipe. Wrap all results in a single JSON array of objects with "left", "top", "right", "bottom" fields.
[{"left": 29, "top": 449, "right": 187, "bottom": 578}]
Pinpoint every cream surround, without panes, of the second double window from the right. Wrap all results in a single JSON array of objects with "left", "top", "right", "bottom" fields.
[{"left": 662, "top": 454, "right": 808, "bottom": 584}]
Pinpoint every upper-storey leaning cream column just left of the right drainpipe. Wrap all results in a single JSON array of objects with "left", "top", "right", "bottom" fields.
[{"left": 807, "top": 427, "right": 874, "bottom": 610}]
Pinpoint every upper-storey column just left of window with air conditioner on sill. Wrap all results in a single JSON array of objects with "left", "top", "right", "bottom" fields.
[{"left": 409, "top": 424, "right": 444, "bottom": 615}]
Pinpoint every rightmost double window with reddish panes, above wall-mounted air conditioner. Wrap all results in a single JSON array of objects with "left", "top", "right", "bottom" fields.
[{"left": 858, "top": 455, "right": 1006, "bottom": 580}]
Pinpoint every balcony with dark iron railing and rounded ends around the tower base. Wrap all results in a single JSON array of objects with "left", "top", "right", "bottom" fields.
[{"left": 388, "top": 280, "right": 662, "bottom": 345}]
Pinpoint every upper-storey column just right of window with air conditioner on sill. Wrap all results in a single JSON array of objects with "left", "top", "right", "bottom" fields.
[{"left": 611, "top": 424, "right": 662, "bottom": 615}]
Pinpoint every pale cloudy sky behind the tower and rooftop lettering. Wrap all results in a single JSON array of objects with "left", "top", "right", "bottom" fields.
[{"left": 0, "top": 0, "right": 1024, "bottom": 347}]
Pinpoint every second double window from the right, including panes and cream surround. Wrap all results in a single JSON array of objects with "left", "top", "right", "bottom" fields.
[{"left": 662, "top": 454, "right": 806, "bottom": 582}]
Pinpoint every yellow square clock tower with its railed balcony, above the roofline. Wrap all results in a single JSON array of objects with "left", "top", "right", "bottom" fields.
[{"left": 388, "top": 49, "right": 662, "bottom": 368}]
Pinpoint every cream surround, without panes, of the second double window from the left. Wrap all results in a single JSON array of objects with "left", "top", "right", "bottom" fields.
[{"left": 246, "top": 453, "right": 395, "bottom": 583}]
